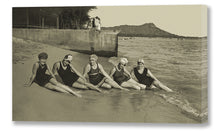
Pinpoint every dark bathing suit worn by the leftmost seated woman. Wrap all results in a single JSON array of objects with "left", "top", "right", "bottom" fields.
[{"left": 34, "top": 63, "right": 53, "bottom": 86}]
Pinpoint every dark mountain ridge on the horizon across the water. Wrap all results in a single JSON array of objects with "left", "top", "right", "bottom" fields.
[{"left": 102, "top": 23, "right": 200, "bottom": 38}]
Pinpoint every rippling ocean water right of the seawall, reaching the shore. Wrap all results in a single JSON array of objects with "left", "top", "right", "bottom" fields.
[{"left": 109, "top": 37, "right": 208, "bottom": 121}]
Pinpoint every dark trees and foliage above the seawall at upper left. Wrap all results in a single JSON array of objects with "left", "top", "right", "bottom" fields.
[{"left": 13, "top": 6, "right": 96, "bottom": 29}]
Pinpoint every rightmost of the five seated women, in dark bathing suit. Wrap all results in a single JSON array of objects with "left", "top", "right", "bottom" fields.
[{"left": 131, "top": 59, "right": 173, "bottom": 92}]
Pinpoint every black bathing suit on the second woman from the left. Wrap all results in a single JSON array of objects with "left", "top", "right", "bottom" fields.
[{"left": 57, "top": 62, "right": 79, "bottom": 87}]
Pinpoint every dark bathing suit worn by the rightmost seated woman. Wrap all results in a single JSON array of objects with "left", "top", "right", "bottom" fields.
[{"left": 134, "top": 67, "right": 154, "bottom": 87}]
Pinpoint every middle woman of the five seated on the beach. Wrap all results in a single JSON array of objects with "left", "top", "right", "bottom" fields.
[{"left": 83, "top": 54, "right": 127, "bottom": 90}]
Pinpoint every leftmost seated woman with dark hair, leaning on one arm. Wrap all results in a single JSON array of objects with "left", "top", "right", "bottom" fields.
[{"left": 25, "top": 52, "right": 81, "bottom": 97}]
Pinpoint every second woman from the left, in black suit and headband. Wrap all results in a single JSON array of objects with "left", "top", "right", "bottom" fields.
[{"left": 52, "top": 54, "right": 102, "bottom": 92}]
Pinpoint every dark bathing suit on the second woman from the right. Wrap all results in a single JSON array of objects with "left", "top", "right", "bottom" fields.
[{"left": 113, "top": 67, "right": 130, "bottom": 85}]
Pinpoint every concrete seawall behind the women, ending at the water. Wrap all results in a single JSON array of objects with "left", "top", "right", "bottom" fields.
[{"left": 13, "top": 28, "right": 119, "bottom": 57}]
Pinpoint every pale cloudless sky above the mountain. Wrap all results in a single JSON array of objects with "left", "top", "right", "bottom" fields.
[{"left": 89, "top": 5, "right": 207, "bottom": 37}]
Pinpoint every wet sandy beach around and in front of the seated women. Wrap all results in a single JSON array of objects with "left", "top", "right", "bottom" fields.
[{"left": 13, "top": 38, "right": 199, "bottom": 123}]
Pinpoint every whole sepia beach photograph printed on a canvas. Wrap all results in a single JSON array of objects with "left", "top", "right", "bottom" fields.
[{"left": 12, "top": 5, "right": 208, "bottom": 124}]
